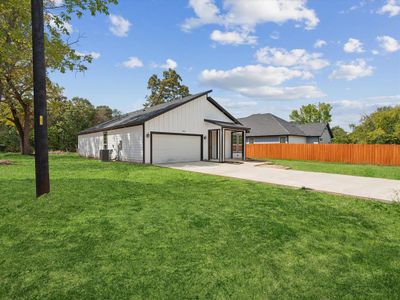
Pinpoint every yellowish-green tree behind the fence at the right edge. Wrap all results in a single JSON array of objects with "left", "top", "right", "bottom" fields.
[{"left": 350, "top": 105, "right": 400, "bottom": 144}]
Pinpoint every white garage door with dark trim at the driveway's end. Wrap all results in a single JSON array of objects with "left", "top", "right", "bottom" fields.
[{"left": 151, "top": 133, "right": 202, "bottom": 164}]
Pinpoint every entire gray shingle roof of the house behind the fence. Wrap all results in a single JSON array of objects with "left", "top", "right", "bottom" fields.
[{"left": 239, "top": 113, "right": 332, "bottom": 137}]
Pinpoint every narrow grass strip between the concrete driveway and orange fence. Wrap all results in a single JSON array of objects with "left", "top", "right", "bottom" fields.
[{"left": 266, "top": 159, "right": 400, "bottom": 180}]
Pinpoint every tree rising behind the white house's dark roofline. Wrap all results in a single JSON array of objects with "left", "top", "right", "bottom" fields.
[{"left": 144, "top": 69, "right": 189, "bottom": 107}]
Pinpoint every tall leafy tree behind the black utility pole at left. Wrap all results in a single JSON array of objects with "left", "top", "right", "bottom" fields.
[{"left": 0, "top": 0, "right": 117, "bottom": 154}]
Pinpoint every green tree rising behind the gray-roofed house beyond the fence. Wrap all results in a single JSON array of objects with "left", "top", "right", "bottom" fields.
[{"left": 290, "top": 103, "right": 332, "bottom": 124}]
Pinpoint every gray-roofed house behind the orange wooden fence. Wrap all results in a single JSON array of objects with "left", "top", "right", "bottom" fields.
[{"left": 239, "top": 113, "right": 333, "bottom": 144}]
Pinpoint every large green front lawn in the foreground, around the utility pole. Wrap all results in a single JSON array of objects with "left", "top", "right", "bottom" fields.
[{"left": 0, "top": 154, "right": 400, "bottom": 299}]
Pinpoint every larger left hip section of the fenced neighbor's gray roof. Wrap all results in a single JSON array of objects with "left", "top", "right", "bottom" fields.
[{"left": 239, "top": 113, "right": 304, "bottom": 136}]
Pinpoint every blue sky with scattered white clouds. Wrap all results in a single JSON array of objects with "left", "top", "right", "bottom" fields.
[{"left": 51, "top": 0, "right": 400, "bottom": 128}]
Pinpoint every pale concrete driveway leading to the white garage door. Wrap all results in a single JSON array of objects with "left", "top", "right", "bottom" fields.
[{"left": 160, "top": 162, "right": 400, "bottom": 202}]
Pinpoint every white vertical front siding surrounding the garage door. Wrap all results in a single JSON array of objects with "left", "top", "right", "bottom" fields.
[{"left": 145, "top": 95, "right": 232, "bottom": 163}]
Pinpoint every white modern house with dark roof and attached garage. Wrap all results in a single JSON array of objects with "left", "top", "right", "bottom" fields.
[{"left": 78, "top": 91, "right": 248, "bottom": 163}]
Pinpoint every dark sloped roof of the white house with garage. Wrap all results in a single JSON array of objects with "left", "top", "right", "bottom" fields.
[{"left": 78, "top": 90, "right": 240, "bottom": 135}]
